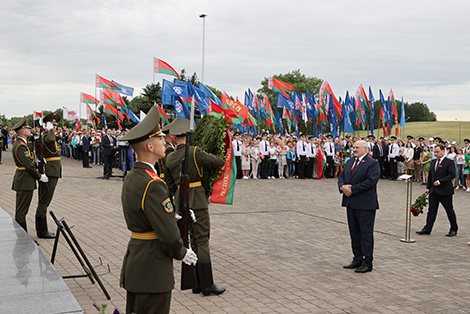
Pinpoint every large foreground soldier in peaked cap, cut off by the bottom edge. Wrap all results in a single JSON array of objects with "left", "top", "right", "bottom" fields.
[{"left": 120, "top": 107, "right": 197, "bottom": 314}]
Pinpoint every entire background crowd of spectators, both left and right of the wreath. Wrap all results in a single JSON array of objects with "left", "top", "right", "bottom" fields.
[{"left": 2, "top": 122, "right": 470, "bottom": 192}]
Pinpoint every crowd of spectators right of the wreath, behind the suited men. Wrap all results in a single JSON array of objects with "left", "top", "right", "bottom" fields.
[{"left": 232, "top": 132, "right": 470, "bottom": 192}]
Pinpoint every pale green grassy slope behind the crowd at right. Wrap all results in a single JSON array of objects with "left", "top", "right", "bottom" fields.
[{"left": 356, "top": 121, "right": 470, "bottom": 145}]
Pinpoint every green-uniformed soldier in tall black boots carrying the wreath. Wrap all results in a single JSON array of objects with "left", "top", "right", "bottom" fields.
[{"left": 165, "top": 119, "right": 225, "bottom": 296}]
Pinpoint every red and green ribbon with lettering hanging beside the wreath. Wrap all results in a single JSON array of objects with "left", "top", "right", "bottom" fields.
[{"left": 211, "top": 129, "right": 237, "bottom": 205}]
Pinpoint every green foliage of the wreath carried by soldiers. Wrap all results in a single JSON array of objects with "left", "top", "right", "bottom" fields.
[{"left": 191, "top": 115, "right": 228, "bottom": 203}]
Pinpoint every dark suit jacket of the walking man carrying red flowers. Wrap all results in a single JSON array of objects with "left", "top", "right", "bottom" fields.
[{"left": 426, "top": 158, "right": 455, "bottom": 195}]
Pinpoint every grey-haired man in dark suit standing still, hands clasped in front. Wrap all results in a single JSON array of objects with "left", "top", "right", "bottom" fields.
[{"left": 338, "top": 141, "right": 380, "bottom": 273}]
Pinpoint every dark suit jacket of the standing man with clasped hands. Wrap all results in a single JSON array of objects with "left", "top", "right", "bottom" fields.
[{"left": 338, "top": 155, "right": 380, "bottom": 210}]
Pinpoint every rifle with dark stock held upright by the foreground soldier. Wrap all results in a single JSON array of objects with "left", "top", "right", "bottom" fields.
[{"left": 178, "top": 132, "right": 197, "bottom": 290}]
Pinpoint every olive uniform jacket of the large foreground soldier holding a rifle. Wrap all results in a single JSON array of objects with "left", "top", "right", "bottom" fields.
[{"left": 121, "top": 162, "right": 186, "bottom": 293}]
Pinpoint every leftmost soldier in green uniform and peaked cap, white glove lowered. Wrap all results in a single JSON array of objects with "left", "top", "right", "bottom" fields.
[{"left": 11, "top": 116, "right": 49, "bottom": 231}]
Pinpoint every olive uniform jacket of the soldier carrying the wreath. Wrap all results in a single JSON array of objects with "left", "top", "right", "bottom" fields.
[{"left": 165, "top": 144, "right": 225, "bottom": 209}]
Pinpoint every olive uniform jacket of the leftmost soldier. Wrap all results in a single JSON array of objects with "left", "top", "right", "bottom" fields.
[{"left": 11, "top": 137, "right": 41, "bottom": 191}]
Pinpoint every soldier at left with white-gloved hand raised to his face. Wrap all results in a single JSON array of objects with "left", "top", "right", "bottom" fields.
[{"left": 36, "top": 112, "right": 62, "bottom": 239}]
